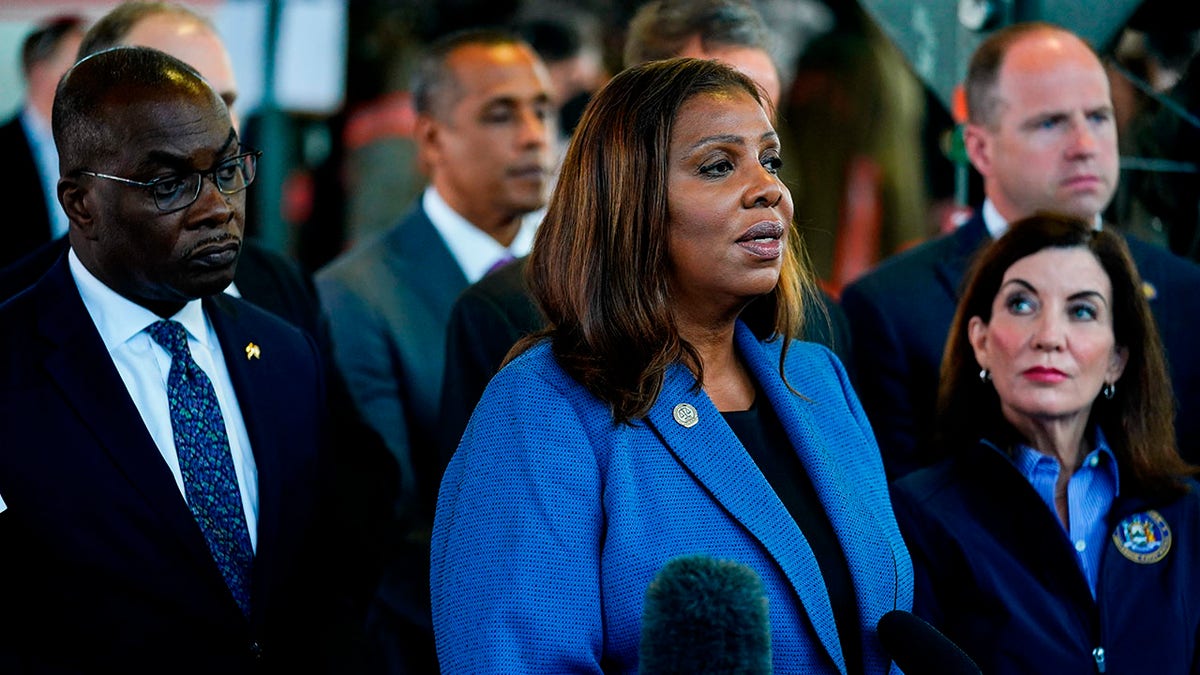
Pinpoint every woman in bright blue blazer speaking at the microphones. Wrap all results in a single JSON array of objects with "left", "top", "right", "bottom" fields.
[{"left": 431, "top": 59, "right": 912, "bottom": 674}]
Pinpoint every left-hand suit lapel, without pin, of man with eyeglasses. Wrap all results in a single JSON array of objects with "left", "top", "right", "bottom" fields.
[{"left": 37, "top": 258, "right": 216, "bottom": 562}]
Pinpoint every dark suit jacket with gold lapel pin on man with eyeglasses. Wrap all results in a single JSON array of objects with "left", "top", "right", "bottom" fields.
[{"left": 0, "top": 255, "right": 326, "bottom": 673}]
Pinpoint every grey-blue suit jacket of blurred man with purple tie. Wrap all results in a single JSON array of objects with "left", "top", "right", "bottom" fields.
[{"left": 317, "top": 201, "right": 467, "bottom": 511}]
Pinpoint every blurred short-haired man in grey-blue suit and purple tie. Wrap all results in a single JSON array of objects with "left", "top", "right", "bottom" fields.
[{"left": 317, "top": 30, "right": 554, "bottom": 673}]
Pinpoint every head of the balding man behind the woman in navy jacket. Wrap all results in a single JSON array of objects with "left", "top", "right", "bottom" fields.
[{"left": 964, "top": 23, "right": 1120, "bottom": 221}]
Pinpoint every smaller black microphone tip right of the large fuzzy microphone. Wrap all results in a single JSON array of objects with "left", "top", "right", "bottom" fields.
[{"left": 877, "top": 609, "right": 983, "bottom": 675}]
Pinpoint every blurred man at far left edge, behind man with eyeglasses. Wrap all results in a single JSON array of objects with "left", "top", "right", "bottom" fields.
[{"left": 0, "top": 17, "right": 84, "bottom": 268}]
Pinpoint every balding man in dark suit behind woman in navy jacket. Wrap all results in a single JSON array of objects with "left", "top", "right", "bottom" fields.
[{"left": 841, "top": 23, "right": 1200, "bottom": 479}]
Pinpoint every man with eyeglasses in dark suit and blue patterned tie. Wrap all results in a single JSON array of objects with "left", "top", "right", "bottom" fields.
[{"left": 0, "top": 48, "right": 326, "bottom": 673}]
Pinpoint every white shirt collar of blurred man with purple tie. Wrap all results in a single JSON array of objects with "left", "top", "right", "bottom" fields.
[{"left": 421, "top": 185, "right": 545, "bottom": 283}]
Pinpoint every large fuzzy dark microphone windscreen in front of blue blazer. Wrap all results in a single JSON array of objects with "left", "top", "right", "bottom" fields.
[{"left": 638, "top": 555, "right": 772, "bottom": 675}]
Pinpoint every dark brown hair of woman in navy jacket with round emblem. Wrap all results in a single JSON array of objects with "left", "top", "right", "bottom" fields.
[{"left": 936, "top": 214, "right": 1196, "bottom": 496}]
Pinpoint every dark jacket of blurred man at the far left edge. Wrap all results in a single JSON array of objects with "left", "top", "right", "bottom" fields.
[{"left": 0, "top": 113, "right": 50, "bottom": 267}]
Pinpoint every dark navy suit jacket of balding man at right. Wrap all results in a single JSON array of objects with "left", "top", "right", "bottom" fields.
[{"left": 841, "top": 214, "right": 1200, "bottom": 478}]
